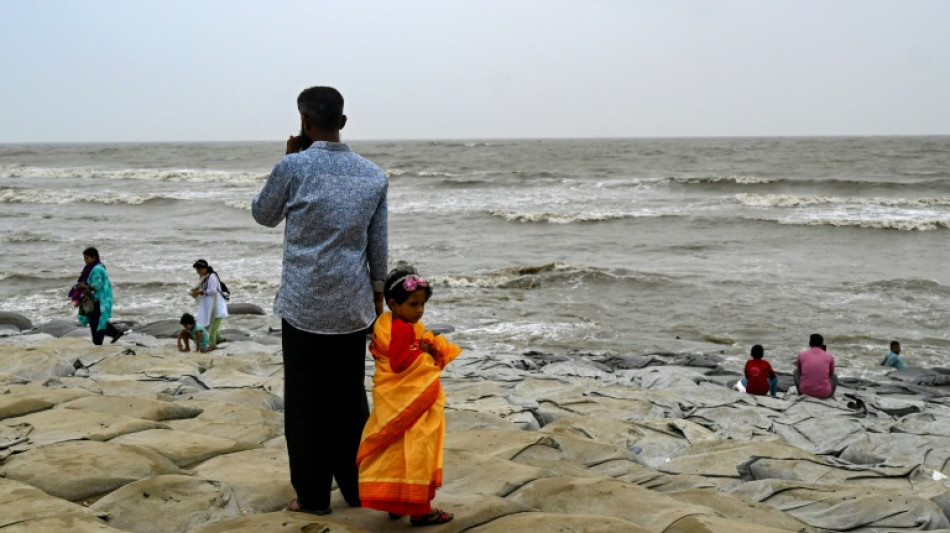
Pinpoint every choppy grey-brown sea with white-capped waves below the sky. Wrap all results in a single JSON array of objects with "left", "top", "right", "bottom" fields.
[{"left": 0, "top": 136, "right": 950, "bottom": 377}]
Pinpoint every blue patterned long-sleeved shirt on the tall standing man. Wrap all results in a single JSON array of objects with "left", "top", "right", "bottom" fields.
[{"left": 251, "top": 141, "right": 388, "bottom": 334}]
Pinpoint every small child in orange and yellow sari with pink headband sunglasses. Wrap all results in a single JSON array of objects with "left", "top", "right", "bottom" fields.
[{"left": 356, "top": 267, "right": 462, "bottom": 526}]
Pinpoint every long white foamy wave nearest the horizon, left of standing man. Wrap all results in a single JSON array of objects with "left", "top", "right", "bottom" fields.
[{"left": 0, "top": 165, "right": 268, "bottom": 184}]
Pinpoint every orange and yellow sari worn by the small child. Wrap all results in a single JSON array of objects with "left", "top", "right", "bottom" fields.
[{"left": 356, "top": 312, "right": 462, "bottom": 515}]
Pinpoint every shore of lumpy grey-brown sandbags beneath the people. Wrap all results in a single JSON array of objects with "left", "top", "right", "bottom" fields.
[{"left": 0, "top": 309, "right": 950, "bottom": 533}]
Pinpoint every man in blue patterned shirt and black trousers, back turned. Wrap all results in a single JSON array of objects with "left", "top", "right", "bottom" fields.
[{"left": 251, "top": 87, "right": 388, "bottom": 515}]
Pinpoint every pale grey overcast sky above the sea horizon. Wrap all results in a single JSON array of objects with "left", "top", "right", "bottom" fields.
[{"left": 0, "top": 0, "right": 950, "bottom": 142}]
